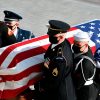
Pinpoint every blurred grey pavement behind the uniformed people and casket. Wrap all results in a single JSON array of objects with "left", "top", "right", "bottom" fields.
[{"left": 0, "top": 0, "right": 100, "bottom": 36}]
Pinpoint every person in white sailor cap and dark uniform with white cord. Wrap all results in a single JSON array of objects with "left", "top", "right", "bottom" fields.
[{"left": 72, "top": 31, "right": 98, "bottom": 100}]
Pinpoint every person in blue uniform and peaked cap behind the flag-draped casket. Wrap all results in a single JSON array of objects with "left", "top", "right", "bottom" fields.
[{"left": 4, "top": 10, "right": 35, "bottom": 42}]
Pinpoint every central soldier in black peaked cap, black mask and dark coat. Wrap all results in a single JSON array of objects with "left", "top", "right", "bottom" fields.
[{"left": 40, "top": 20, "right": 76, "bottom": 100}]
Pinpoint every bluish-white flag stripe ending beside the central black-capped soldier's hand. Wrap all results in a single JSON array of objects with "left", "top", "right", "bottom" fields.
[{"left": 0, "top": 53, "right": 44, "bottom": 75}]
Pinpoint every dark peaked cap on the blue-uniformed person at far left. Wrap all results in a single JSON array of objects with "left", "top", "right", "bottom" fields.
[{"left": 4, "top": 10, "right": 22, "bottom": 21}]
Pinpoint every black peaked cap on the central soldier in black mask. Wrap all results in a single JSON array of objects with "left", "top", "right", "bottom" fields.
[{"left": 47, "top": 20, "right": 70, "bottom": 35}]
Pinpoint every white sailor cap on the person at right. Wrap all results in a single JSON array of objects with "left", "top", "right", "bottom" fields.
[{"left": 74, "top": 31, "right": 90, "bottom": 41}]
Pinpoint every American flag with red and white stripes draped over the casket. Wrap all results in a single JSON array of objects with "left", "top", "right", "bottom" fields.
[{"left": 0, "top": 20, "right": 100, "bottom": 99}]
